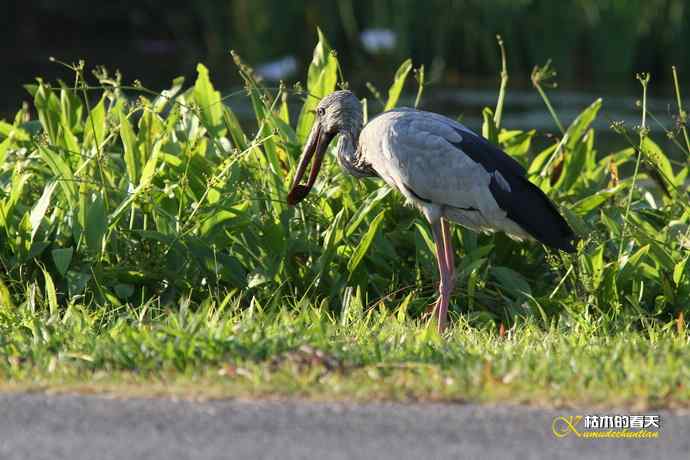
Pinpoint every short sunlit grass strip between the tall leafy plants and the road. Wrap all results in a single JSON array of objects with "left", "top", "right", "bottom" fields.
[{"left": 0, "top": 302, "right": 690, "bottom": 408}]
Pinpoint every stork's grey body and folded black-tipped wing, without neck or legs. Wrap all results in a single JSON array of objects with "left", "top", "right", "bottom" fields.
[{"left": 360, "top": 109, "right": 575, "bottom": 250}]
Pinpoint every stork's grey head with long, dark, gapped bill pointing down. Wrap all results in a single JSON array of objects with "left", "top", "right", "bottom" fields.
[{"left": 288, "top": 90, "right": 362, "bottom": 206}]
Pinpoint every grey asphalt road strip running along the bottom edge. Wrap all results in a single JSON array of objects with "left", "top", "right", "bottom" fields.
[{"left": 0, "top": 394, "right": 690, "bottom": 460}]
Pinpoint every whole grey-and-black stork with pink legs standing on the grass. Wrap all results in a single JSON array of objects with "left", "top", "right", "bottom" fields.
[{"left": 288, "top": 90, "right": 576, "bottom": 332}]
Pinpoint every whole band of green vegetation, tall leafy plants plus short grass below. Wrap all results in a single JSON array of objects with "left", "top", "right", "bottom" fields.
[{"left": 0, "top": 35, "right": 690, "bottom": 406}]
